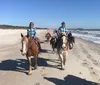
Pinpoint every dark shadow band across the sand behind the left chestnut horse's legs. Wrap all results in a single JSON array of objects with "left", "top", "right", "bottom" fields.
[{"left": 0, "top": 58, "right": 59, "bottom": 73}]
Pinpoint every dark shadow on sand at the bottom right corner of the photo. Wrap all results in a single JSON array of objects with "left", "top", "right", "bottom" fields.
[{"left": 44, "top": 75, "right": 100, "bottom": 85}]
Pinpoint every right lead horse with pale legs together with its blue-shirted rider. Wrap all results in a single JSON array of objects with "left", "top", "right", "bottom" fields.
[{"left": 57, "top": 22, "right": 69, "bottom": 70}]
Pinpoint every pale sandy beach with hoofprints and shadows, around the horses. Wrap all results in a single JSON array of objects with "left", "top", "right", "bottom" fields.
[{"left": 0, "top": 29, "right": 100, "bottom": 85}]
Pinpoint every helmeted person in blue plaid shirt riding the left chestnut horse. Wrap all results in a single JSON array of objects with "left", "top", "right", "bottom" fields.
[{"left": 27, "top": 22, "right": 41, "bottom": 51}]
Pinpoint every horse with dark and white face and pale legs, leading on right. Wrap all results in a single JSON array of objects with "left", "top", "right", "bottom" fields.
[{"left": 57, "top": 33, "right": 68, "bottom": 70}]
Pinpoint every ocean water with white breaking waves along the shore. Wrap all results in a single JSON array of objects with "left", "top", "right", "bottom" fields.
[{"left": 72, "top": 30, "right": 100, "bottom": 44}]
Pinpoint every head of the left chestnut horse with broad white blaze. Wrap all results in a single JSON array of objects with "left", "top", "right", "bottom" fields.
[{"left": 20, "top": 33, "right": 28, "bottom": 55}]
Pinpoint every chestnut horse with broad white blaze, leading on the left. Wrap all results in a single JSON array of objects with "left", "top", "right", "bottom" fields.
[{"left": 21, "top": 34, "right": 39, "bottom": 75}]
